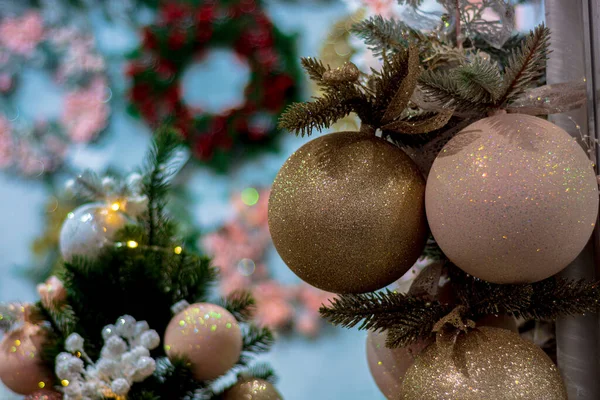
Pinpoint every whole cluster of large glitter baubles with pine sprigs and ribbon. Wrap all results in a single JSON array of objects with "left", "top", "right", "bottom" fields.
[{"left": 269, "top": 13, "right": 599, "bottom": 400}]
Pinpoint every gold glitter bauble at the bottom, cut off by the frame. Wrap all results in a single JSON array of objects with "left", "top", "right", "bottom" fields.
[{"left": 399, "top": 327, "right": 567, "bottom": 400}]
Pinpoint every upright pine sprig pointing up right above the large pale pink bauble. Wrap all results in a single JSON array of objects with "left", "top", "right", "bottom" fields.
[{"left": 498, "top": 24, "right": 550, "bottom": 106}]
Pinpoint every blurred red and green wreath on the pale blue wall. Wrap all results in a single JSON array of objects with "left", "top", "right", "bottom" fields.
[{"left": 127, "top": 0, "right": 300, "bottom": 170}]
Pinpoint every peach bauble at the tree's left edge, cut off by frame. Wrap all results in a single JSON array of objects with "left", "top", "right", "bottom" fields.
[{"left": 0, "top": 322, "right": 52, "bottom": 395}]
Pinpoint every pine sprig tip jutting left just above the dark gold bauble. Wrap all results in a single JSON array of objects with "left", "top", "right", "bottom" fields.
[{"left": 279, "top": 93, "right": 355, "bottom": 136}]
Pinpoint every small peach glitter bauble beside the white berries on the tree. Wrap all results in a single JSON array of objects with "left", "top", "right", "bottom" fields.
[{"left": 164, "top": 303, "right": 242, "bottom": 380}]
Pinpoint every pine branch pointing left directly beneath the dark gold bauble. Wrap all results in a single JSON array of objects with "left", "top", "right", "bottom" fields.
[{"left": 319, "top": 290, "right": 450, "bottom": 334}]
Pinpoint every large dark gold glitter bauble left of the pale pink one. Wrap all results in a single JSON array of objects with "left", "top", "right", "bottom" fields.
[{"left": 269, "top": 132, "right": 427, "bottom": 293}]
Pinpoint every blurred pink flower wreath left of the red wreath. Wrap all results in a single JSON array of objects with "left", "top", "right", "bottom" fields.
[{"left": 0, "top": 11, "right": 110, "bottom": 176}]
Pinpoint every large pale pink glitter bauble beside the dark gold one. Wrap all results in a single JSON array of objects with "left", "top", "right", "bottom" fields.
[{"left": 425, "top": 114, "right": 598, "bottom": 283}]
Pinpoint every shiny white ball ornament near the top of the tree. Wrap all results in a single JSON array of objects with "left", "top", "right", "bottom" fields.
[{"left": 59, "top": 203, "right": 127, "bottom": 261}]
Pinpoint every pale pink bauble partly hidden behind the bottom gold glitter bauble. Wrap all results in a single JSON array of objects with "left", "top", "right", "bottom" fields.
[{"left": 367, "top": 332, "right": 433, "bottom": 399}]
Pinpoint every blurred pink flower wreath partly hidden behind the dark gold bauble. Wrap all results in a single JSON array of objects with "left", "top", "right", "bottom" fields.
[{"left": 202, "top": 190, "right": 334, "bottom": 337}]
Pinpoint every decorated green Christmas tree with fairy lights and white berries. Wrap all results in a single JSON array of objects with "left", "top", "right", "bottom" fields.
[{"left": 0, "top": 129, "right": 274, "bottom": 400}]
